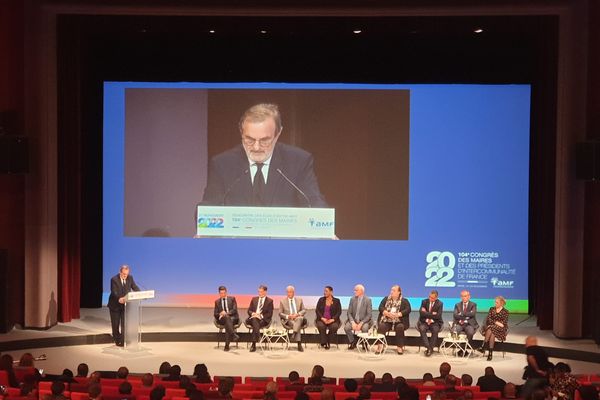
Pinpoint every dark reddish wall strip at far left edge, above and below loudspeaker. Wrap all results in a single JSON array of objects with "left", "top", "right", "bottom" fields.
[{"left": 0, "top": 0, "right": 25, "bottom": 332}]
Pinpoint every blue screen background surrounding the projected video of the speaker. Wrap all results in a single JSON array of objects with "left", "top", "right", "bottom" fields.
[{"left": 102, "top": 82, "right": 530, "bottom": 310}]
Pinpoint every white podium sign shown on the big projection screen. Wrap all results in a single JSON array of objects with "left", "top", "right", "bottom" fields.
[{"left": 196, "top": 206, "right": 335, "bottom": 239}]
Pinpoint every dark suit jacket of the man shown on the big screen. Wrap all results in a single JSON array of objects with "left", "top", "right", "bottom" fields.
[{"left": 202, "top": 142, "right": 328, "bottom": 207}]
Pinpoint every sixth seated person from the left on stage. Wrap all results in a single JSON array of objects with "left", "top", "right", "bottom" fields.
[{"left": 377, "top": 285, "right": 410, "bottom": 354}]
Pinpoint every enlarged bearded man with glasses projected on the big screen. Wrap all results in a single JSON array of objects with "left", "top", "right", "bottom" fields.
[{"left": 202, "top": 104, "right": 327, "bottom": 207}]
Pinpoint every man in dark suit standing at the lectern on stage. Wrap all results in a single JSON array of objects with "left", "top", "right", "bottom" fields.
[{"left": 108, "top": 265, "right": 140, "bottom": 346}]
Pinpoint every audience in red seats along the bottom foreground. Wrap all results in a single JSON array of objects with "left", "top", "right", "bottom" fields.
[{"left": 0, "top": 356, "right": 600, "bottom": 400}]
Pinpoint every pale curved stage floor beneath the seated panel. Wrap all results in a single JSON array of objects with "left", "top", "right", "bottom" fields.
[{"left": 0, "top": 307, "right": 600, "bottom": 384}]
